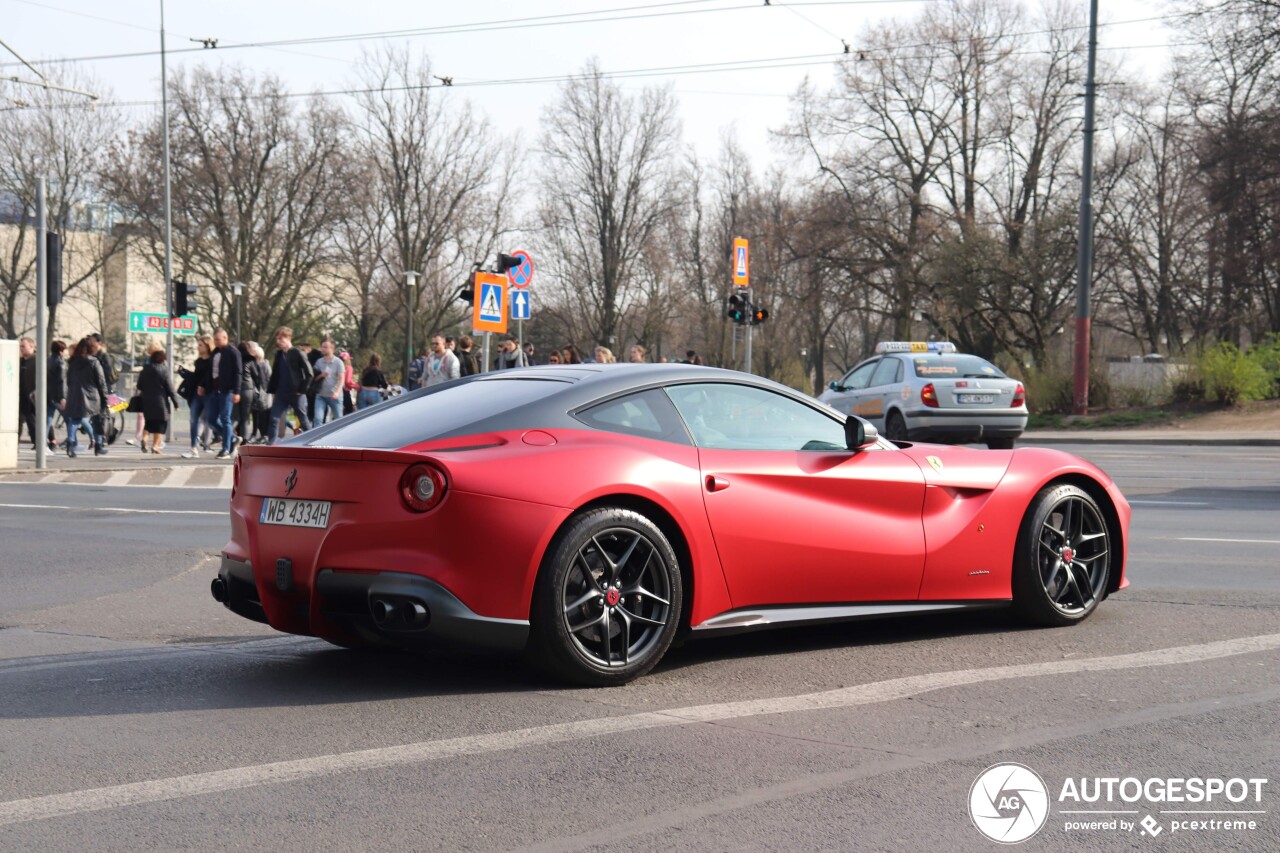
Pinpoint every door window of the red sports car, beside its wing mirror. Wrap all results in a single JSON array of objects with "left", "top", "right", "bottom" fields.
[{"left": 667, "top": 383, "right": 845, "bottom": 451}]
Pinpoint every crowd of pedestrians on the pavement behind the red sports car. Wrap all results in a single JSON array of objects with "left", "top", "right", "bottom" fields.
[{"left": 18, "top": 327, "right": 703, "bottom": 459}]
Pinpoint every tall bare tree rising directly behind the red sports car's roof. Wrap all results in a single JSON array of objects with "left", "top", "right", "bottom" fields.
[{"left": 541, "top": 60, "right": 680, "bottom": 348}]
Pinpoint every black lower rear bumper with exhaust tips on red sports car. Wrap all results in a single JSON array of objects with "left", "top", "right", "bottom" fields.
[{"left": 214, "top": 556, "right": 529, "bottom": 652}]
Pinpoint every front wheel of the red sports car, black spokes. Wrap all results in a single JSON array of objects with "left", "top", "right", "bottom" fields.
[{"left": 1012, "top": 484, "right": 1111, "bottom": 626}]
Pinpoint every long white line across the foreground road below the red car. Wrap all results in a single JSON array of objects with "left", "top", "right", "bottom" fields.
[{"left": 0, "top": 634, "right": 1280, "bottom": 826}]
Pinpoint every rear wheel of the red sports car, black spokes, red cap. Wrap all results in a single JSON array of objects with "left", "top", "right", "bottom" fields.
[{"left": 529, "top": 507, "right": 684, "bottom": 686}]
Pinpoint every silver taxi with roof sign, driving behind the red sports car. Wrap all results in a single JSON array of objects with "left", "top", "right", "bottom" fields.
[{"left": 818, "top": 341, "right": 1027, "bottom": 450}]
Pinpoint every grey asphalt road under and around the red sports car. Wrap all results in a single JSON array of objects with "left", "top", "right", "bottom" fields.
[{"left": 0, "top": 446, "right": 1280, "bottom": 850}]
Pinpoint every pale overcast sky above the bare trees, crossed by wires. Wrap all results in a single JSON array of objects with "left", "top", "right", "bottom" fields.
[{"left": 0, "top": 0, "right": 1175, "bottom": 165}]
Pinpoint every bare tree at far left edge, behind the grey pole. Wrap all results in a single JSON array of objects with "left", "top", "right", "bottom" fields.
[{"left": 0, "top": 67, "right": 124, "bottom": 338}]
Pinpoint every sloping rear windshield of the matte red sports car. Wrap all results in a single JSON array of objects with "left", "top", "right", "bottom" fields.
[{"left": 303, "top": 378, "right": 566, "bottom": 450}]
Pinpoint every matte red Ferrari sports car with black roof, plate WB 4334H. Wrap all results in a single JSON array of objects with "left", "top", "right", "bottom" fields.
[{"left": 212, "top": 365, "right": 1129, "bottom": 684}]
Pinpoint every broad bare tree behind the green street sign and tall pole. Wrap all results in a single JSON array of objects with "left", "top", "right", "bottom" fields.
[{"left": 101, "top": 68, "right": 344, "bottom": 337}]
